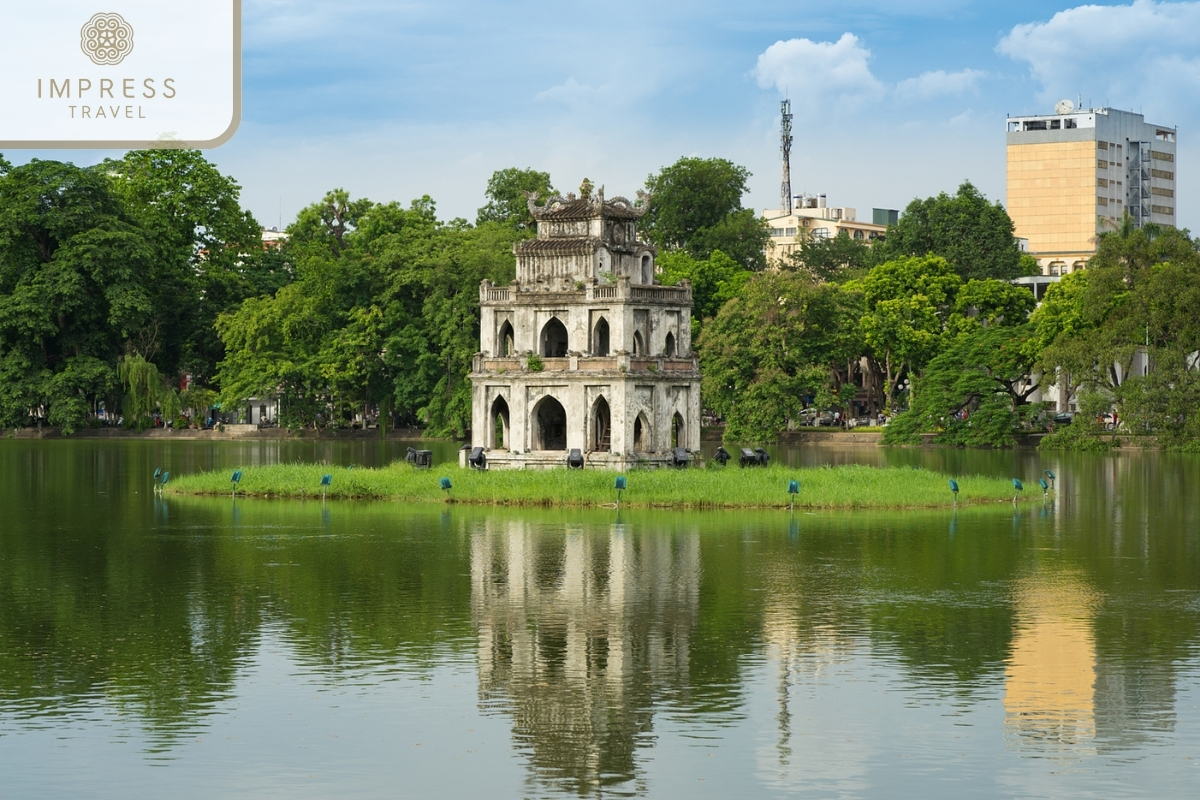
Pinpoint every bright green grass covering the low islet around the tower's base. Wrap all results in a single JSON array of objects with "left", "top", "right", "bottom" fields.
[{"left": 167, "top": 462, "right": 1040, "bottom": 509}]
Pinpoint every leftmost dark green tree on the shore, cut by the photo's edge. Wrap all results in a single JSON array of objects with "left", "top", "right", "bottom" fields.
[{"left": 0, "top": 160, "right": 155, "bottom": 432}]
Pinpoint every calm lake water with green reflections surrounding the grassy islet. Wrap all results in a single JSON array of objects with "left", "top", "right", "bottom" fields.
[{"left": 0, "top": 440, "right": 1200, "bottom": 799}]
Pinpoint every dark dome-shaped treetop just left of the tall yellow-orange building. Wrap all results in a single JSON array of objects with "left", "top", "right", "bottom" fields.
[{"left": 884, "top": 181, "right": 1025, "bottom": 281}]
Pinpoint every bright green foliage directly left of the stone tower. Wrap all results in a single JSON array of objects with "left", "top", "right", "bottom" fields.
[{"left": 216, "top": 192, "right": 524, "bottom": 435}]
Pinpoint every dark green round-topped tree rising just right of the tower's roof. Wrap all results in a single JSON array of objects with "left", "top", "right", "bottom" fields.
[{"left": 641, "top": 158, "right": 770, "bottom": 271}]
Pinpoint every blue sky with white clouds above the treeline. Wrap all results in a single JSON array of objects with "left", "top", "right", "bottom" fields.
[{"left": 5, "top": 0, "right": 1200, "bottom": 230}]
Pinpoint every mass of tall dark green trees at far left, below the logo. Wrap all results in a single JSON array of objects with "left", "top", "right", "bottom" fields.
[{"left": 0, "top": 150, "right": 274, "bottom": 432}]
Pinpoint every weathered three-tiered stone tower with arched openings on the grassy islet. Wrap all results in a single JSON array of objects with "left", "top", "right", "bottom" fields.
[{"left": 470, "top": 181, "right": 700, "bottom": 469}]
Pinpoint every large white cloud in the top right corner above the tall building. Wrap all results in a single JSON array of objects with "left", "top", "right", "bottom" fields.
[{"left": 996, "top": 0, "right": 1200, "bottom": 121}]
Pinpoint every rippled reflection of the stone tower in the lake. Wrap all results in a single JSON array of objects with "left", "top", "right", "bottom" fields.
[{"left": 470, "top": 519, "right": 701, "bottom": 794}]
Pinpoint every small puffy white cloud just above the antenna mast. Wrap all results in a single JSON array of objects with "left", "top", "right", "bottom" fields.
[{"left": 755, "top": 34, "right": 883, "bottom": 106}]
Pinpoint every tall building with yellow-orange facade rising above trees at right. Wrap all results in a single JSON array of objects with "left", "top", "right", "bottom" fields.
[{"left": 1007, "top": 100, "right": 1176, "bottom": 275}]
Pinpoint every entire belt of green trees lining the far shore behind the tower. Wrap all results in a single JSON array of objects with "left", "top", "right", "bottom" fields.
[{"left": 9, "top": 150, "right": 1200, "bottom": 449}]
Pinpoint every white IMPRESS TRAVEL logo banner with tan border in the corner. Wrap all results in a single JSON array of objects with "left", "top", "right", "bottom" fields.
[{"left": 0, "top": 0, "right": 241, "bottom": 149}]
